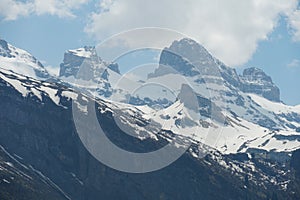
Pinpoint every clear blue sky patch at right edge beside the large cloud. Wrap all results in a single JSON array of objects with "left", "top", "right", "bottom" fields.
[{"left": 240, "top": 16, "right": 300, "bottom": 104}]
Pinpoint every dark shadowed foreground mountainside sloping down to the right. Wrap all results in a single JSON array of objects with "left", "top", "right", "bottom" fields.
[{"left": 0, "top": 68, "right": 298, "bottom": 199}]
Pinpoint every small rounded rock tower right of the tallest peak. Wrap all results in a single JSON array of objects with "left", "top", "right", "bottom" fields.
[{"left": 241, "top": 67, "right": 280, "bottom": 102}]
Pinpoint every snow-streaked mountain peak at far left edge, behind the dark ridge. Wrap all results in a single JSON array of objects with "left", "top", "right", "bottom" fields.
[{"left": 0, "top": 39, "right": 50, "bottom": 79}]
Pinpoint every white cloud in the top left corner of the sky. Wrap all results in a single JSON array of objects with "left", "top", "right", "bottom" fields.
[{"left": 0, "top": 0, "right": 88, "bottom": 20}]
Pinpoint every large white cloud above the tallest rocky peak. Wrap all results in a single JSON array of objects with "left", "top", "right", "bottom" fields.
[{"left": 86, "top": 0, "right": 300, "bottom": 65}]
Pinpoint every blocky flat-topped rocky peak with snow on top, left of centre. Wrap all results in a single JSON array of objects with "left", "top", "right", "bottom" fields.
[{"left": 59, "top": 46, "right": 121, "bottom": 97}]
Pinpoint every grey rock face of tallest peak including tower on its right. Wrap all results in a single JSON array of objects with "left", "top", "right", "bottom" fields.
[{"left": 156, "top": 38, "right": 280, "bottom": 102}]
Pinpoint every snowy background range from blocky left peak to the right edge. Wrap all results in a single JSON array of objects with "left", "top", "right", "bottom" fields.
[{"left": 48, "top": 38, "right": 300, "bottom": 154}]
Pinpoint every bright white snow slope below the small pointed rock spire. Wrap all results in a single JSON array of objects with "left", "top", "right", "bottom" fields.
[{"left": 135, "top": 85, "right": 300, "bottom": 154}]
